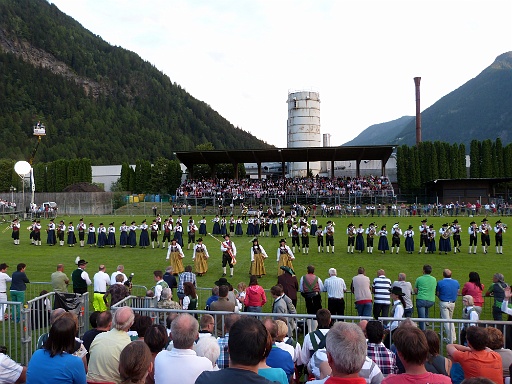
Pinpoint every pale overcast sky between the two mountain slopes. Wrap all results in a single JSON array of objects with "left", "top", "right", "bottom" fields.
[{"left": 50, "top": 0, "right": 512, "bottom": 147}]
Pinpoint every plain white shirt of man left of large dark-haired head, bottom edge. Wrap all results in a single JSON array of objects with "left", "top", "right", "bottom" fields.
[{"left": 155, "top": 348, "right": 213, "bottom": 384}]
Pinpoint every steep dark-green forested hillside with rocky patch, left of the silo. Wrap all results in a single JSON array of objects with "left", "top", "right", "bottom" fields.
[{"left": 0, "top": 0, "right": 268, "bottom": 165}]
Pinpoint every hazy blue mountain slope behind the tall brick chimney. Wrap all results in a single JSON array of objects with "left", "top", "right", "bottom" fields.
[{"left": 344, "top": 52, "right": 512, "bottom": 150}]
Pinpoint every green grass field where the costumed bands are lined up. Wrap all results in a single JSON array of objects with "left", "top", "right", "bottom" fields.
[{"left": 0, "top": 212, "right": 512, "bottom": 319}]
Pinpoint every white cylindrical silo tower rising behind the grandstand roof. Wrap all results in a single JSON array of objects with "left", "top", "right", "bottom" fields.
[{"left": 287, "top": 91, "right": 322, "bottom": 176}]
